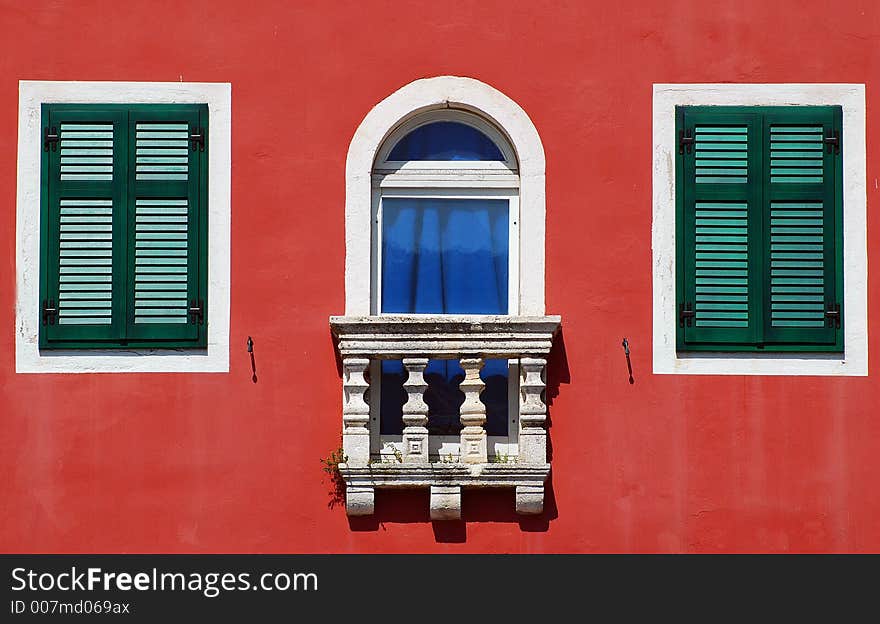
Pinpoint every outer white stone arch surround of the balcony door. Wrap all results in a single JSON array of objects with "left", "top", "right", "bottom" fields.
[{"left": 345, "top": 76, "right": 545, "bottom": 315}]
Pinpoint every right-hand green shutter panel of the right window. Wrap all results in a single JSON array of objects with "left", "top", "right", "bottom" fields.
[{"left": 763, "top": 107, "right": 843, "bottom": 346}]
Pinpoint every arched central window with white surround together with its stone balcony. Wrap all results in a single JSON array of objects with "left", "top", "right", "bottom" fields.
[{"left": 330, "top": 76, "right": 560, "bottom": 520}]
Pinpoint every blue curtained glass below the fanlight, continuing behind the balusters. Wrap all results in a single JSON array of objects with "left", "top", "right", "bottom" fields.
[{"left": 380, "top": 198, "right": 509, "bottom": 435}]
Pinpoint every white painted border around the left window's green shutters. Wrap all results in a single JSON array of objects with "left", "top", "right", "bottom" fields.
[{"left": 15, "top": 80, "right": 232, "bottom": 373}]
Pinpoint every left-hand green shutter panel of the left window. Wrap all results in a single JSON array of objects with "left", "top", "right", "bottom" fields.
[{"left": 40, "top": 105, "right": 127, "bottom": 347}]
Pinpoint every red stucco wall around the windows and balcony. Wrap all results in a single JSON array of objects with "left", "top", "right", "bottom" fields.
[{"left": 0, "top": 0, "right": 880, "bottom": 552}]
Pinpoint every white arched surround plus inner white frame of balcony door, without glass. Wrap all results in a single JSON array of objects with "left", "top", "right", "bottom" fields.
[{"left": 345, "top": 76, "right": 545, "bottom": 456}]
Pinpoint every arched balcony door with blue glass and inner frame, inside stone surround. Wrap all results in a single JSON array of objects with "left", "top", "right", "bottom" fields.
[{"left": 371, "top": 109, "right": 519, "bottom": 456}]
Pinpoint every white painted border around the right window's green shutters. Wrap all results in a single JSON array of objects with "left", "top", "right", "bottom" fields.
[{"left": 651, "top": 84, "right": 868, "bottom": 376}]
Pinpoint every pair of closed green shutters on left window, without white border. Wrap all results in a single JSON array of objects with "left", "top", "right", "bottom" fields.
[{"left": 40, "top": 104, "right": 208, "bottom": 349}]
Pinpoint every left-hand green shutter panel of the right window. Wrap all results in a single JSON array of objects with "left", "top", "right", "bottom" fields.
[{"left": 677, "top": 108, "right": 762, "bottom": 350}]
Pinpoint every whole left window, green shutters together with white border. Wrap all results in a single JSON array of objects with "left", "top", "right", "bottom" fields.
[{"left": 15, "top": 81, "right": 231, "bottom": 373}]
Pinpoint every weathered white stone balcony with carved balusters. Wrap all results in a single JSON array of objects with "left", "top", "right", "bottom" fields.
[{"left": 330, "top": 315, "right": 560, "bottom": 520}]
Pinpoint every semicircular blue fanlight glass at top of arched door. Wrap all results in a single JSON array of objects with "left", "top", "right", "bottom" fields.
[{"left": 388, "top": 121, "right": 504, "bottom": 160}]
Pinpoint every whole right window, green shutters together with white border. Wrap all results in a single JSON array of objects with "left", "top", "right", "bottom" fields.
[{"left": 651, "top": 83, "right": 868, "bottom": 375}]
